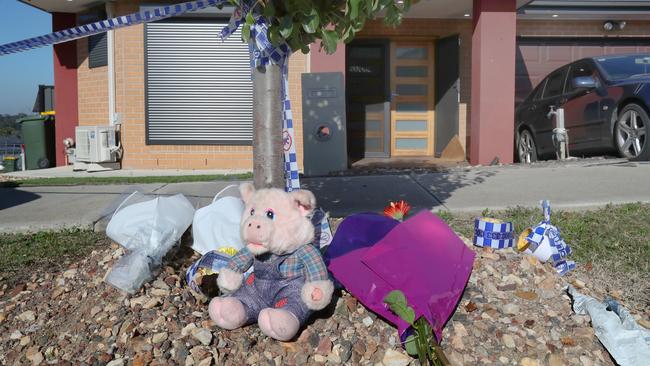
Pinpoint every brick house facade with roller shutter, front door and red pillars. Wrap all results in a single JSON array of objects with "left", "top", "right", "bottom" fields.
[{"left": 23, "top": 0, "right": 650, "bottom": 169}]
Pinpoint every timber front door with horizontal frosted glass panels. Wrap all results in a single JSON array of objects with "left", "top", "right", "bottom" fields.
[{"left": 390, "top": 41, "right": 434, "bottom": 156}]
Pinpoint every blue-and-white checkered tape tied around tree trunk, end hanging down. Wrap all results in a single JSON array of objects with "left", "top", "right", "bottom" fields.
[{"left": 221, "top": 0, "right": 300, "bottom": 192}]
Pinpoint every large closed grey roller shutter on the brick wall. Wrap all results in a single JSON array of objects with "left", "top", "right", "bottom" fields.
[{"left": 145, "top": 19, "right": 253, "bottom": 145}]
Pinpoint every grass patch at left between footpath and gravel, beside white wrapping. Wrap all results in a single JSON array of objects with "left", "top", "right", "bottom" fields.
[{"left": 0, "top": 229, "right": 109, "bottom": 283}]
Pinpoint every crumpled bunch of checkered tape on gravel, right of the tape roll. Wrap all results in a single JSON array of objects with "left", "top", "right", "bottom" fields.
[{"left": 517, "top": 200, "right": 576, "bottom": 275}]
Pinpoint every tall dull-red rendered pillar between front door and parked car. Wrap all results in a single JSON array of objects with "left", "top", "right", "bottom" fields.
[{"left": 470, "top": 0, "right": 517, "bottom": 164}]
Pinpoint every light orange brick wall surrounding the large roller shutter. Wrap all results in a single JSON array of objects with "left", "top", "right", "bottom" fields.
[{"left": 78, "top": 1, "right": 307, "bottom": 170}]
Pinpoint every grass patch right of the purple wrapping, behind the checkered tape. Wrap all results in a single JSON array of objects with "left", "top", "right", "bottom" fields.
[{"left": 438, "top": 203, "right": 650, "bottom": 311}]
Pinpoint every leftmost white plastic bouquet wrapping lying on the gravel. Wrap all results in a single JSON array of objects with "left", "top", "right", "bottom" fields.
[{"left": 106, "top": 192, "right": 194, "bottom": 294}]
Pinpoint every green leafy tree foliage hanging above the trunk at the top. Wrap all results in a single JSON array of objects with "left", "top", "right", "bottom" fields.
[{"left": 230, "top": 0, "right": 411, "bottom": 54}]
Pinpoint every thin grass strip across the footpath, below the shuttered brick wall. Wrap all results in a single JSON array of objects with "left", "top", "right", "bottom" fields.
[{"left": 0, "top": 173, "right": 253, "bottom": 187}]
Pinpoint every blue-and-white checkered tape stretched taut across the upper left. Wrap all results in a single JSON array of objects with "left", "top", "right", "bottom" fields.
[{"left": 0, "top": 0, "right": 228, "bottom": 56}]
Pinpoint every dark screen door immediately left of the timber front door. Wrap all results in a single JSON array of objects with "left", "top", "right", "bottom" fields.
[{"left": 345, "top": 40, "right": 390, "bottom": 161}]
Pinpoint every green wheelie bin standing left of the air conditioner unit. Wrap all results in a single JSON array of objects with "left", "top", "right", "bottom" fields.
[{"left": 18, "top": 116, "right": 56, "bottom": 170}]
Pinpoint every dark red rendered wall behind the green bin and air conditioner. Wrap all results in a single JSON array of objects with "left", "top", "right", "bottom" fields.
[{"left": 52, "top": 13, "right": 79, "bottom": 166}]
